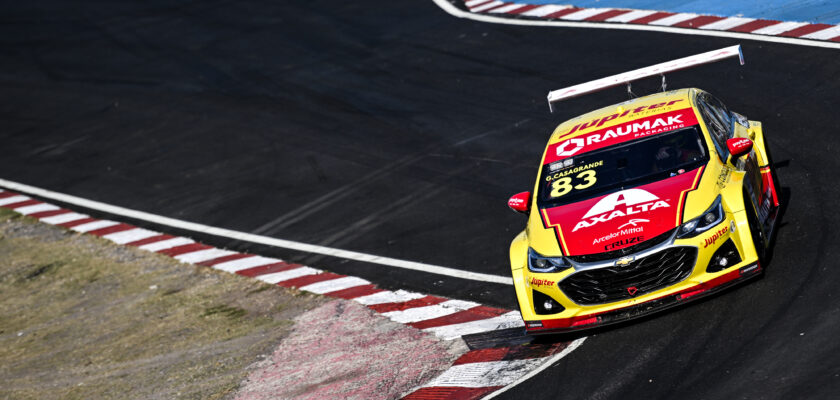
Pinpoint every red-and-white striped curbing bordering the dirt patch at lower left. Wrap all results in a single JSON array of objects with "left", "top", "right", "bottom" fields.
[{"left": 0, "top": 189, "right": 582, "bottom": 399}]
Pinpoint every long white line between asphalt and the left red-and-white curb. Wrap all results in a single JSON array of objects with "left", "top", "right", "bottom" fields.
[{"left": 0, "top": 177, "right": 512, "bottom": 285}]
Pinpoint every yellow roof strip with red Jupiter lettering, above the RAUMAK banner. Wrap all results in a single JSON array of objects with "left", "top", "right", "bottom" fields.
[{"left": 548, "top": 88, "right": 698, "bottom": 144}]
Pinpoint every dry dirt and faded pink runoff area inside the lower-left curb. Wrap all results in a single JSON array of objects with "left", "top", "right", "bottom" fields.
[{"left": 0, "top": 210, "right": 467, "bottom": 399}]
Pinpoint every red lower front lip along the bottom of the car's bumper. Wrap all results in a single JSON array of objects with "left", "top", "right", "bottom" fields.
[{"left": 525, "top": 262, "right": 762, "bottom": 335}]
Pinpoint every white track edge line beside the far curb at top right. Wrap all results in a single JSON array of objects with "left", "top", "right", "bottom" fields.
[{"left": 430, "top": 0, "right": 840, "bottom": 50}]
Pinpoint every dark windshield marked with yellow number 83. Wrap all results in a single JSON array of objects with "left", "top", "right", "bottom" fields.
[{"left": 537, "top": 125, "right": 709, "bottom": 208}]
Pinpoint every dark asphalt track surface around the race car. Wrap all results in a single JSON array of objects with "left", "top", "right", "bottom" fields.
[{"left": 0, "top": 0, "right": 840, "bottom": 399}]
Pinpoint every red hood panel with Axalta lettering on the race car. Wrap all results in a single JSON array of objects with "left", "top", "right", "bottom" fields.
[{"left": 540, "top": 167, "right": 704, "bottom": 256}]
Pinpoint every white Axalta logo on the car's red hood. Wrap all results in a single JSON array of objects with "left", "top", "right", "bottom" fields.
[{"left": 572, "top": 189, "right": 670, "bottom": 232}]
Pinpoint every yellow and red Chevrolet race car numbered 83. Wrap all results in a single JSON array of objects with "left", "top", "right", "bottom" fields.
[{"left": 508, "top": 46, "right": 780, "bottom": 334}]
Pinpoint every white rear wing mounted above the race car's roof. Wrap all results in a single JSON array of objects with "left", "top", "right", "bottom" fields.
[{"left": 548, "top": 45, "right": 744, "bottom": 112}]
